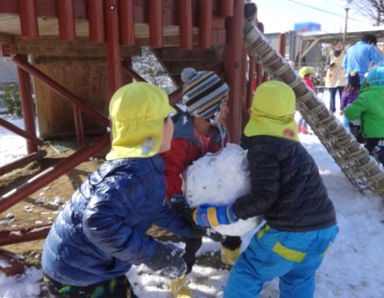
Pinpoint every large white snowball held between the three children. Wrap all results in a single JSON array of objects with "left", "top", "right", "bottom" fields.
[{"left": 184, "top": 144, "right": 258, "bottom": 236}]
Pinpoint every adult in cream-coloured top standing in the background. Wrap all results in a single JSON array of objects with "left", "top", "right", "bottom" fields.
[{"left": 325, "top": 40, "right": 345, "bottom": 113}]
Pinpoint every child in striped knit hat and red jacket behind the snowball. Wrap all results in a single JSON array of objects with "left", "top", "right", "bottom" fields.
[{"left": 162, "top": 68, "right": 241, "bottom": 297}]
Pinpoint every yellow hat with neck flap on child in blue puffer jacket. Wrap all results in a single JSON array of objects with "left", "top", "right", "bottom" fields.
[{"left": 106, "top": 82, "right": 176, "bottom": 160}]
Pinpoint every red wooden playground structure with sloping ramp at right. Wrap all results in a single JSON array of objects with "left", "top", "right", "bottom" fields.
[{"left": 0, "top": 0, "right": 384, "bottom": 274}]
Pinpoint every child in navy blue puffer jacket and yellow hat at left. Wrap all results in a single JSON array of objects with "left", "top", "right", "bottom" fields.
[{"left": 42, "top": 82, "right": 192, "bottom": 298}]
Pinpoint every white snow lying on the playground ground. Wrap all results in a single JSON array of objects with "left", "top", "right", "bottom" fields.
[{"left": 0, "top": 94, "right": 384, "bottom": 298}]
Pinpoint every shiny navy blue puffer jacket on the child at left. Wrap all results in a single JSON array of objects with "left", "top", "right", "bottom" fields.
[{"left": 42, "top": 155, "right": 191, "bottom": 286}]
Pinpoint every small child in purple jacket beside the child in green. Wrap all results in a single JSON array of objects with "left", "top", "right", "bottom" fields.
[{"left": 340, "top": 71, "right": 364, "bottom": 143}]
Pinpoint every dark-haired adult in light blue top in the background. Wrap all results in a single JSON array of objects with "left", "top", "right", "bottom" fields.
[{"left": 342, "top": 34, "right": 383, "bottom": 84}]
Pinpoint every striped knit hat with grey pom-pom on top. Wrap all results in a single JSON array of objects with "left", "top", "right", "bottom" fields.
[{"left": 181, "top": 68, "right": 229, "bottom": 120}]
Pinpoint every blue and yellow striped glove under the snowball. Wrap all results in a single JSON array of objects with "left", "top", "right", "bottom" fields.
[{"left": 192, "top": 205, "right": 238, "bottom": 228}]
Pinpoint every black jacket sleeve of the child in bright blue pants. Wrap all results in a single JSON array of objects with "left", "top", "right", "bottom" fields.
[{"left": 233, "top": 145, "right": 280, "bottom": 219}]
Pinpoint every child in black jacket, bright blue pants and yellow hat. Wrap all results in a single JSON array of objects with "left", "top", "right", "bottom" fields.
[{"left": 192, "top": 81, "right": 338, "bottom": 298}]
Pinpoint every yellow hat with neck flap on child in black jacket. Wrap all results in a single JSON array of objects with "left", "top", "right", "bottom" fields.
[{"left": 244, "top": 81, "right": 299, "bottom": 141}]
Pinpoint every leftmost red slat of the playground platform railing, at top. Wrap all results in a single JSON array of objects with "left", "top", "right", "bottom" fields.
[{"left": 18, "top": 0, "right": 39, "bottom": 38}]
